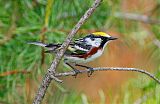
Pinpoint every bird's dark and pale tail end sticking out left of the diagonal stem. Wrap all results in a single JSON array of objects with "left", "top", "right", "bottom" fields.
[{"left": 28, "top": 42, "right": 61, "bottom": 53}]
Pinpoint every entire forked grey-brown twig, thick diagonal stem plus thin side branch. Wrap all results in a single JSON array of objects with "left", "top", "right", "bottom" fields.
[{"left": 33, "top": 0, "right": 160, "bottom": 104}]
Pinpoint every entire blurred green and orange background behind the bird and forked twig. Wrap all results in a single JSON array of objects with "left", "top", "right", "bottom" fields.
[{"left": 0, "top": 0, "right": 160, "bottom": 104}]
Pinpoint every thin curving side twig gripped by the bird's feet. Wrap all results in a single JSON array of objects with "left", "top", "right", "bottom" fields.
[{"left": 55, "top": 67, "right": 160, "bottom": 84}]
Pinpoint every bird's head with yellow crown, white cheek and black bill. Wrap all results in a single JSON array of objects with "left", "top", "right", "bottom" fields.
[{"left": 85, "top": 32, "right": 117, "bottom": 48}]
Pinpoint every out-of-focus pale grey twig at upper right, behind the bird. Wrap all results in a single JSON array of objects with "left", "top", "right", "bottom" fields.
[{"left": 114, "top": 12, "right": 160, "bottom": 25}]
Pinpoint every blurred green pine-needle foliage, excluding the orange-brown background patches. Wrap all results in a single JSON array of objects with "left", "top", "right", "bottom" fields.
[{"left": 0, "top": 0, "right": 160, "bottom": 104}]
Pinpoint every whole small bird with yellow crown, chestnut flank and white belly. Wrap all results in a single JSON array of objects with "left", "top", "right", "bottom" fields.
[{"left": 28, "top": 32, "right": 118, "bottom": 77}]
